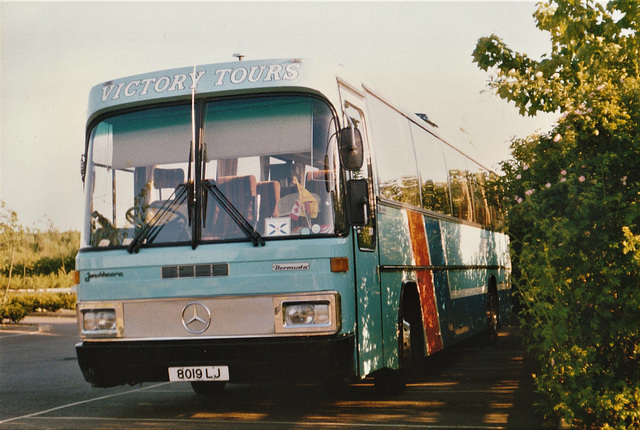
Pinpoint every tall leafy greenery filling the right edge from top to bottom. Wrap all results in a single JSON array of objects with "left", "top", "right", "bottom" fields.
[{"left": 473, "top": 0, "right": 640, "bottom": 428}]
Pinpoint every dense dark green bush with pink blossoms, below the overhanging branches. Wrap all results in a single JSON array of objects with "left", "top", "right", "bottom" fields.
[{"left": 503, "top": 128, "right": 640, "bottom": 428}]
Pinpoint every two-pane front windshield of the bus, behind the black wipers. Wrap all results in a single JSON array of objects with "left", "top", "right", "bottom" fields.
[{"left": 83, "top": 96, "right": 346, "bottom": 248}]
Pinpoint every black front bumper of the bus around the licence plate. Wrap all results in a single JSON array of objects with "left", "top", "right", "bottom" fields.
[{"left": 76, "top": 334, "right": 355, "bottom": 387}]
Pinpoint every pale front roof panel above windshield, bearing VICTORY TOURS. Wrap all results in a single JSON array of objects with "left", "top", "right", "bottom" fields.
[{"left": 87, "top": 58, "right": 344, "bottom": 123}]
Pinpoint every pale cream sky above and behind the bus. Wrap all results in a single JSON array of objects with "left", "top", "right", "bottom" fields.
[{"left": 0, "top": 0, "right": 555, "bottom": 230}]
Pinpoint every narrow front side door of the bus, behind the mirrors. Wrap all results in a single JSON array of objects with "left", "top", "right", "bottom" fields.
[{"left": 339, "top": 81, "right": 384, "bottom": 377}]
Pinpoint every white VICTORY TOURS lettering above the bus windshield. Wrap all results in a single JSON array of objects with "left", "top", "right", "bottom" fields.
[{"left": 102, "top": 63, "right": 300, "bottom": 102}]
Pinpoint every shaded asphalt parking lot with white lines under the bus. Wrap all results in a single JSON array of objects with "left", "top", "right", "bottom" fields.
[{"left": 0, "top": 315, "right": 544, "bottom": 429}]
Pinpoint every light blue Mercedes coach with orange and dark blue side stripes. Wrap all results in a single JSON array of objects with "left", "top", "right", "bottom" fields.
[{"left": 76, "top": 59, "right": 511, "bottom": 395}]
